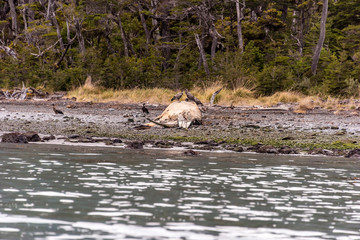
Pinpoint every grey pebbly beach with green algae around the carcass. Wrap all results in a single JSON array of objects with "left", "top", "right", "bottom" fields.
[{"left": 0, "top": 99, "right": 360, "bottom": 157}]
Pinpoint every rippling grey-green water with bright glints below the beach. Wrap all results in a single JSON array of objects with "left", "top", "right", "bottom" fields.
[{"left": 0, "top": 144, "right": 360, "bottom": 240}]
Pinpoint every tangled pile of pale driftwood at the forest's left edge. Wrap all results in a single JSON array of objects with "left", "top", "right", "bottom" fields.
[{"left": 0, "top": 86, "right": 48, "bottom": 100}]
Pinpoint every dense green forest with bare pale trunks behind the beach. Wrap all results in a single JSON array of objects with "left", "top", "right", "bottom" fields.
[{"left": 0, "top": 0, "right": 360, "bottom": 97}]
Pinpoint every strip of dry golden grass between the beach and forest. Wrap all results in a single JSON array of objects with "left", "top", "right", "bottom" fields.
[{"left": 67, "top": 84, "right": 359, "bottom": 113}]
